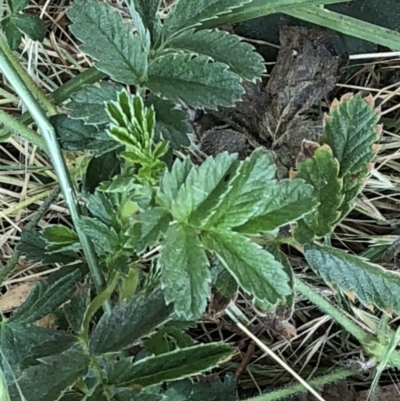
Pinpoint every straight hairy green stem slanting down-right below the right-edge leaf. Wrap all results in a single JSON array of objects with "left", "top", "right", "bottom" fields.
[{"left": 295, "top": 277, "right": 370, "bottom": 345}]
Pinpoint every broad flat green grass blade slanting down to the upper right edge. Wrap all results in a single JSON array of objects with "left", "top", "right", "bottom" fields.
[{"left": 282, "top": 7, "right": 400, "bottom": 50}]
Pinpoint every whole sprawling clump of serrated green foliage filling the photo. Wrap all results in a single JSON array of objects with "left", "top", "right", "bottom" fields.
[{"left": 0, "top": 0, "right": 400, "bottom": 401}]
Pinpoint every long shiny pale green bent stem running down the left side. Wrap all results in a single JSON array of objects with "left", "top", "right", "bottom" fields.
[{"left": 0, "top": 45, "right": 111, "bottom": 312}]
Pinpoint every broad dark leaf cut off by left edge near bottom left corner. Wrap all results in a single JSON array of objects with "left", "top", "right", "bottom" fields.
[{"left": 0, "top": 322, "right": 77, "bottom": 382}]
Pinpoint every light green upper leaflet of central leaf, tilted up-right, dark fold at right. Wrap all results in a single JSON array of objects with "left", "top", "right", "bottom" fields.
[{"left": 159, "top": 152, "right": 237, "bottom": 222}]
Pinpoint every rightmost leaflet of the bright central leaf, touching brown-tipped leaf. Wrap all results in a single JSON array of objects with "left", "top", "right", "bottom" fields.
[{"left": 235, "top": 180, "right": 318, "bottom": 235}]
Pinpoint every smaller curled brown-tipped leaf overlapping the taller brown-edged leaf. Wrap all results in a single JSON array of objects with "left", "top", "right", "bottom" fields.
[{"left": 295, "top": 145, "right": 343, "bottom": 244}]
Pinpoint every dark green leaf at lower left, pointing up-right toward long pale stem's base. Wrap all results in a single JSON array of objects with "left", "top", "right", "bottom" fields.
[{"left": 10, "top": 270, "right": 82, "bottom": 323}]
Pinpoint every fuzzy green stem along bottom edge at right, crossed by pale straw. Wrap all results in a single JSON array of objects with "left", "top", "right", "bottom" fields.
[{"left": 246, "top": 369, "right": 359, "bottom": 401}]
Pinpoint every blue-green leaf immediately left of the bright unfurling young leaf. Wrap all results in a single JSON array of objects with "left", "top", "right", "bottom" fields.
[{"left": 68, "top": 82, "right": 122, "bottom": 125}]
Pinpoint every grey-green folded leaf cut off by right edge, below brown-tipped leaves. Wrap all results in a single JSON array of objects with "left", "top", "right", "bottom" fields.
[{"left": 304, "top": 243, "right": 400, "bottom": 313}]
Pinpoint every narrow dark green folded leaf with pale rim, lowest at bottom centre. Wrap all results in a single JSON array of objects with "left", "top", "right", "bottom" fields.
[{"left": 108, "top": 343, "right": 234, "bottom": 386}]
